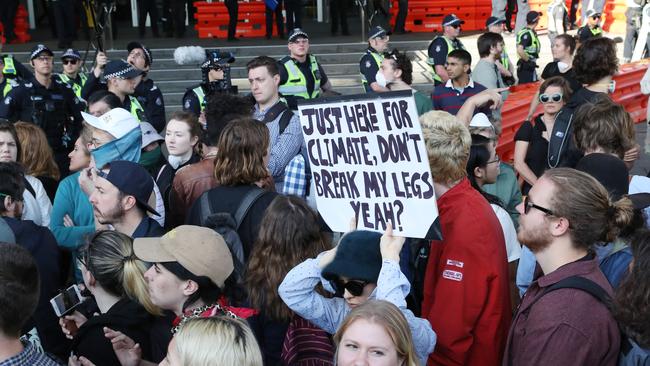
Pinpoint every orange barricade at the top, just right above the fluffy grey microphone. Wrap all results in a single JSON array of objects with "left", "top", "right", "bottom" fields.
[{"left": 194, "top": 0, "right": 277, "bottom": 38}]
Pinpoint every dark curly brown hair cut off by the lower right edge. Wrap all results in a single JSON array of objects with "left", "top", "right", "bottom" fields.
[{"left": 612, "top": 230, "right": 650, "bottom": 349}]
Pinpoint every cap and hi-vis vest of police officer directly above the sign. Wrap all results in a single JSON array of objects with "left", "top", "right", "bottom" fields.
[{"left": 280, "top": 29, "right": 328, "bottom": 110}]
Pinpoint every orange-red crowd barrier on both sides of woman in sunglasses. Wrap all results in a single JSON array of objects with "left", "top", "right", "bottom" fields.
[{"left": 497, "top": 59, "right": 650, "bottom": 162}]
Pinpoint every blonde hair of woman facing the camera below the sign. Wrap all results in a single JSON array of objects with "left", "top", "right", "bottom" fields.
[{"left": 334, "top": 300, "right": 420, "bottom": 366}]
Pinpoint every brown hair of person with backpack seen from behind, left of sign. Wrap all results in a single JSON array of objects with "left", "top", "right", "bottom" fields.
[{"left": 214, "top": 118, "right": 270, "bottom": 186}]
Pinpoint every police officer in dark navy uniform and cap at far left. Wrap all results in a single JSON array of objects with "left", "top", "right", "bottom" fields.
[{"left": 0, "top": 44, "right": 83, "bottom": 176}]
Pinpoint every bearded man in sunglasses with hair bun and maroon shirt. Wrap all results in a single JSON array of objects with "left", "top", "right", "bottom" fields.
[{"left": 503, "top": 168, "right": 633, "bottom": 365}]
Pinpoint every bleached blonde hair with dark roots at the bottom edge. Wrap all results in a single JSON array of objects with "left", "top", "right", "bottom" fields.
[{"left": 174, "top": 316, "right": 263, "bottom": 366}]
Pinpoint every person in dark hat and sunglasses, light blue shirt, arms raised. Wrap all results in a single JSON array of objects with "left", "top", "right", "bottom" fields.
[{"left": 278, "top": 229, "right": 436, "bottom": 364}]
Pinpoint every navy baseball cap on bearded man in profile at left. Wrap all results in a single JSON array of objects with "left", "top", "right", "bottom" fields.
[{"left": 97, "top": 160, "right": 160, "bottom": 216}]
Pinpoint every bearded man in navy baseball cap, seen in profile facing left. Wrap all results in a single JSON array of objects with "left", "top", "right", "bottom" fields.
[{"left": 90, "top": 160, "right": 165, "bottom": 238}]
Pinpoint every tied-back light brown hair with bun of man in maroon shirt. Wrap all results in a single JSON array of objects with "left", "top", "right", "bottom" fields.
[{"left": 542, "top": 168, "right": 634, "bottom": 249}]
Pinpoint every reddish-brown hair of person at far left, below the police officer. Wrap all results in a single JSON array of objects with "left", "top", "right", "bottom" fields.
[{"left": 14, "top": 122, "right": 61, "bottom": 180}]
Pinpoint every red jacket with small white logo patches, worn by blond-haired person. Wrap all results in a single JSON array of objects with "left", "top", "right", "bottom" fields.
[{"left": 422, "top": 179, "right": 512, "bottom": 366}]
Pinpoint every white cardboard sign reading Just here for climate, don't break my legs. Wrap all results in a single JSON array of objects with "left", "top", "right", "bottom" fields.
[{"left": 298, "top": 91, "right": 441, "bottom": 239}]
